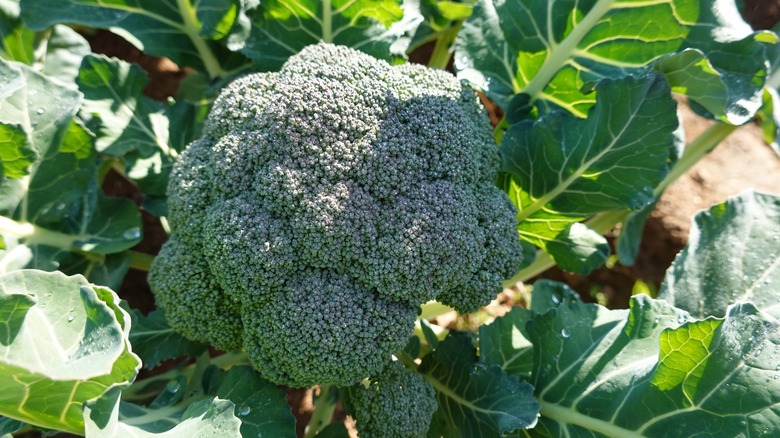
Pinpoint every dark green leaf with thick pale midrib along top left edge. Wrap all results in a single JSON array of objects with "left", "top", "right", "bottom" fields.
[{"left": 21, "top": 0, "right": 241, "bottom": 77}]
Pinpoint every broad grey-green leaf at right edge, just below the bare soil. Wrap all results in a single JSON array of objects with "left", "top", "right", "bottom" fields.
[{"left": 659, "top": 191, "right": 780, "bottom": 318}]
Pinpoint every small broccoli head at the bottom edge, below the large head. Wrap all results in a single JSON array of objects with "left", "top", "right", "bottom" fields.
[{"left": 343, "top": 362, "right": 438, "bottom": 438}]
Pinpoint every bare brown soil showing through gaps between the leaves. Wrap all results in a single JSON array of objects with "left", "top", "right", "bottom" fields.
[{"left": 87, "top": 0, "right": 780, "bottom": 435}]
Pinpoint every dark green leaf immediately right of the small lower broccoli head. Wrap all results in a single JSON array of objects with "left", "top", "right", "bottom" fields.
[{"left": 419, "top": 332, "right": 539, "bottom": 437}]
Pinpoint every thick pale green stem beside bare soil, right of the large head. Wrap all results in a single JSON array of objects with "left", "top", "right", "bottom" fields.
[{"left": 504, "top": 122, "right": 738, "bottom": 287}]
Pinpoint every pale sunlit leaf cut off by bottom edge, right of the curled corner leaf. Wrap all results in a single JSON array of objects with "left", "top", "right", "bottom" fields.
[{"left": 84, "top": 391, "right": 241, "bottom": 438}]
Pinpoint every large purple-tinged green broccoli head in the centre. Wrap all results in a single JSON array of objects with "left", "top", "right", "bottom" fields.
[{"left": 150, "top": 43, "right": 522, "bottom": 386}]
